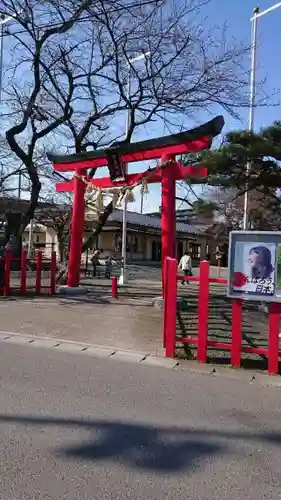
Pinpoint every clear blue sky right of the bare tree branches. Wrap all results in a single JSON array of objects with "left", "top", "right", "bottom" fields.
[{"left": 126, "top": 0, "right": 281, "bottom": 212}]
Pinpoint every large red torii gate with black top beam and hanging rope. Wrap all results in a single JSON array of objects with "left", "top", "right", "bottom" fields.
[{"left": 48, "top": 116, "right": 224, "bottom": 287}]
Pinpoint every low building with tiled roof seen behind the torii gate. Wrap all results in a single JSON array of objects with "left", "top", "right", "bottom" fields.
[{"left": 20, "top": 209, "right": 208, "bottom": 262}]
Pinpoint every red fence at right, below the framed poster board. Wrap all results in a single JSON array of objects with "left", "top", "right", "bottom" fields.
[{"left": 163, "top": 258, "right": 281, "bottom": 374}]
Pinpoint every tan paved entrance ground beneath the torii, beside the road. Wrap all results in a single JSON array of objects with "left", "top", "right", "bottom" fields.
[{"left": 0, "top": 266, "right": 214, "bottom": 355}]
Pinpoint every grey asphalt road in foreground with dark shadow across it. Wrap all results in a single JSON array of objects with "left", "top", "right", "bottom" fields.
[{"left": 0, "top": 343, "right": 281, "bottom": 500}]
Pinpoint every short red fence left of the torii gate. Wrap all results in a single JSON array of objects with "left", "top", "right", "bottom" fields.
[{"left": 0, "top": 250, "right": 57, "bottom": 297}]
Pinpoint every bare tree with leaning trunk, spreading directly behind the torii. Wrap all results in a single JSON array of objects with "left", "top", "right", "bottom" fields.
[{"left": 36, "top": 0, "right": 247, "bottom": 262}]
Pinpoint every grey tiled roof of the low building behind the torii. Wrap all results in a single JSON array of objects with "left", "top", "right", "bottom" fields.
[{"left": 108, "top": 210, "right": 208, "bottom": 235}]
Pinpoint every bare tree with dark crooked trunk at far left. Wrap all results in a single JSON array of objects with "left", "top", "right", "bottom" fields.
[{"left": 0, "top": 0, "right": 166, "bottom": 249}]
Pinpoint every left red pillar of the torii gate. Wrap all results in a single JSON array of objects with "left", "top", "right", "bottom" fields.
[{"left": 67, "top": 169, "right": 86, "bottom": 287}]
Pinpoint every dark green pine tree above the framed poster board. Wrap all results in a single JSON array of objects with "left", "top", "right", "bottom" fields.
[{"left": 185, "top": 121, "right": 281, "bottom": 230}]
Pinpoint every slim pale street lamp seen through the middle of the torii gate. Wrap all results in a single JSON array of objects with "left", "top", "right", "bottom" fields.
[{"left": 119, "top": 52, "right": 150, "bottom": 285}]
